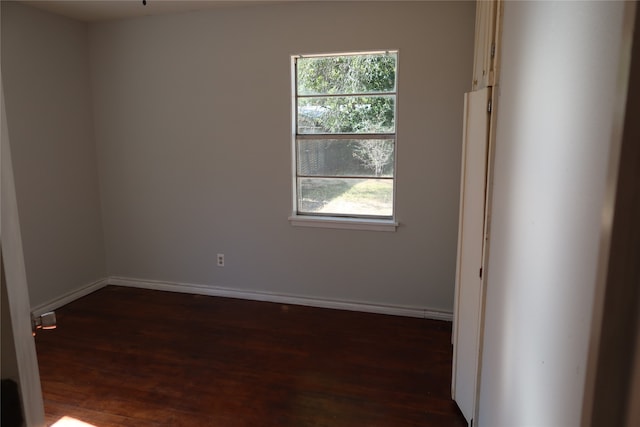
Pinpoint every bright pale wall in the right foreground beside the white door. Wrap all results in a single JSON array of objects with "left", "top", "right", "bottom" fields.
[{"left": 475, "top": 2, "right": 628, "bottom": 427}]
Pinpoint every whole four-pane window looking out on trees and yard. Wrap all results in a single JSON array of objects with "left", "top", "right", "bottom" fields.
[{"left": 293, "top": 52, "right": 398, "bottom": 227}]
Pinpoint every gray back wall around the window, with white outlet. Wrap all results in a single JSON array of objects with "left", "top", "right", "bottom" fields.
[{"left": 89, "top": 2, "right": 475, "bottom": 312}]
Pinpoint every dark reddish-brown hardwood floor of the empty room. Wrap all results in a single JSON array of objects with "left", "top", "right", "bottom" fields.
[{"left": 36, "top": 286, "right": 466, "bottom": 427}]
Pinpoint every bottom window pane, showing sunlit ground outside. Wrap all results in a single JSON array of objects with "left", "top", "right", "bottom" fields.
[{"left": 298, "top": 178, "right": 393, "bottom": 217}]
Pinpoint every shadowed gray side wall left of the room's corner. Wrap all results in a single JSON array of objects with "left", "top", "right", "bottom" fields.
[{"left": 2, "top": 1, "right": 106, "bottom": 306}]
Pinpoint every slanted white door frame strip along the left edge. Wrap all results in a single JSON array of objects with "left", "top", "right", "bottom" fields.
[{"left": 0, "top": 78, "right": 45, "bottom": 427}]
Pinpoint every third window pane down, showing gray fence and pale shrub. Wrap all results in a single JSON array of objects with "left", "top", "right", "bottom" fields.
[{"left": 297, "top": 139, "right": 394, "bottom": 178}]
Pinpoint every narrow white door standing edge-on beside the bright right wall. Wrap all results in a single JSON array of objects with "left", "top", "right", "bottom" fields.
[{"left": 451, "top": 88, "right": 491, "bottom": 423}]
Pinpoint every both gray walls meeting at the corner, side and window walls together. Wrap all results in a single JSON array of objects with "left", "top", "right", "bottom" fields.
[{"left": 2, "top": 2, "right": 475, "bottom": 311}]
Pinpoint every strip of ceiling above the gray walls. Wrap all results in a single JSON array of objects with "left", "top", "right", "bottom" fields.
[{"left": 21, "top": 0, "right": 300, "bottom": 22}]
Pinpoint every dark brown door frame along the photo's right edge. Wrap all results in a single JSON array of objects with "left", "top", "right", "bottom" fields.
[{"left": 581, "top": 1, "right": 640, "bottom": 427}]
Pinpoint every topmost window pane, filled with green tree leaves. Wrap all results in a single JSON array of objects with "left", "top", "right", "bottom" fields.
[{"left": 296, "top": 53, "right": 397, "bottom": 95}]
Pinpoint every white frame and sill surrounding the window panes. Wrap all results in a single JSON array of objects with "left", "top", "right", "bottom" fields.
[{"left": 289, "top": 49, "right": 400, "bottom": 231}]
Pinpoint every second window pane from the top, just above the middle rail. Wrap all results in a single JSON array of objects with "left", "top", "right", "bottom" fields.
[{"left": 298, "top": 95, "right": 395, "bottom": 134}]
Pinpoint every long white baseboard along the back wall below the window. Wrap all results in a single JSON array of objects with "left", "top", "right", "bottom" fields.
[{"left": 107, "top": 276, "right": 453, "bottom": 321}]
